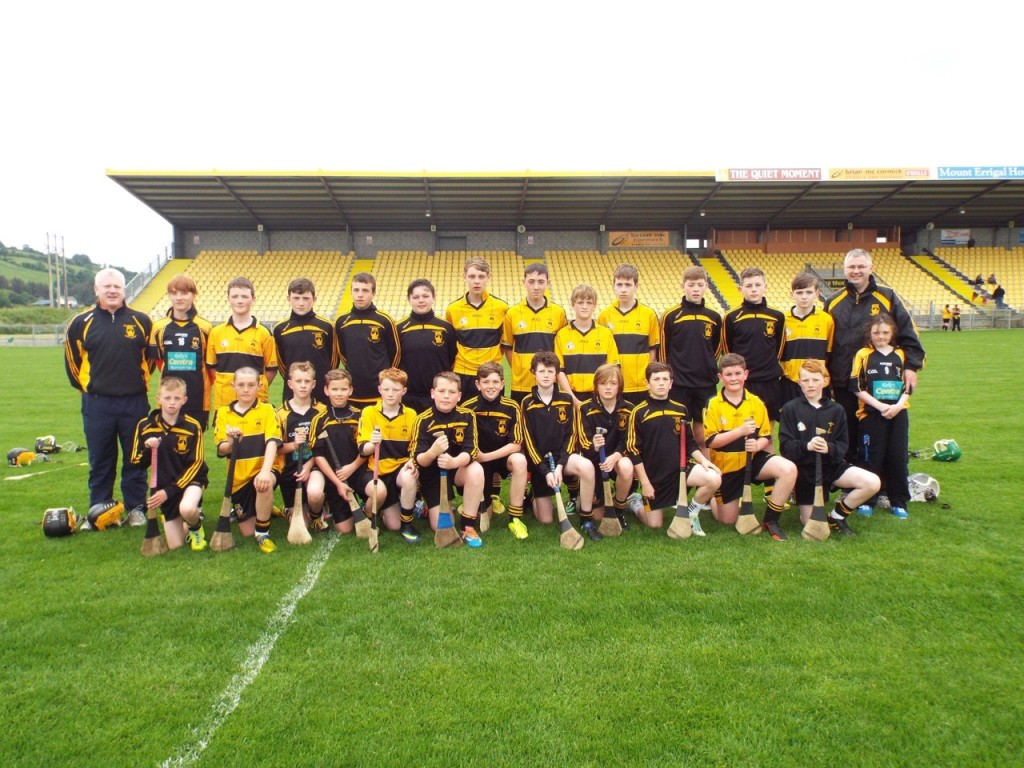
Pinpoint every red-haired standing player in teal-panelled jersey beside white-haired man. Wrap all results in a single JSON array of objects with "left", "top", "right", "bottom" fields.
[{"left": 150, "top": 274, "right": 213, "bottom": 429}]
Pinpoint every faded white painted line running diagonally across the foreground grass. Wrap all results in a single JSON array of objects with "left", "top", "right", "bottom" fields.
[{"left": 161, "top": 536, "right": 339, "bottom": 768}]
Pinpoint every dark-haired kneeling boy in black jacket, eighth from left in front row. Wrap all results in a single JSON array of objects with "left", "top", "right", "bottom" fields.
[{"left": 522, "top": 352, "right": 603, "bottom": 541}]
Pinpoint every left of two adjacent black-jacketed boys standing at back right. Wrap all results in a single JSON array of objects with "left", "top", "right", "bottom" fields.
[{"left": 658, "top": 266, "right": 722, "bottom": 449}]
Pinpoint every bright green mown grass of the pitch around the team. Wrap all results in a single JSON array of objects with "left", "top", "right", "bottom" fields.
[{"left": 0, "top": 331, "right": 1024, "bottom": 767}]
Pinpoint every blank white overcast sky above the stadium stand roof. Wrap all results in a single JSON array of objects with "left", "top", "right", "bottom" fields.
[{"left": 0, "top": 0, "right": 1024, "bottom": 268}]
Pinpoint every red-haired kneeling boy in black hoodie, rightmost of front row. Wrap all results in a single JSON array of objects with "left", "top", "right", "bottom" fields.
[{"left": 778, "top": 359, "right": 881, "bottom": 536}]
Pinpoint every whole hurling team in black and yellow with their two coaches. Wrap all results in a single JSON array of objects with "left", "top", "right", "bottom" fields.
[{"left": 65, "top": 249, "right": 925, "bottom": 553}]
